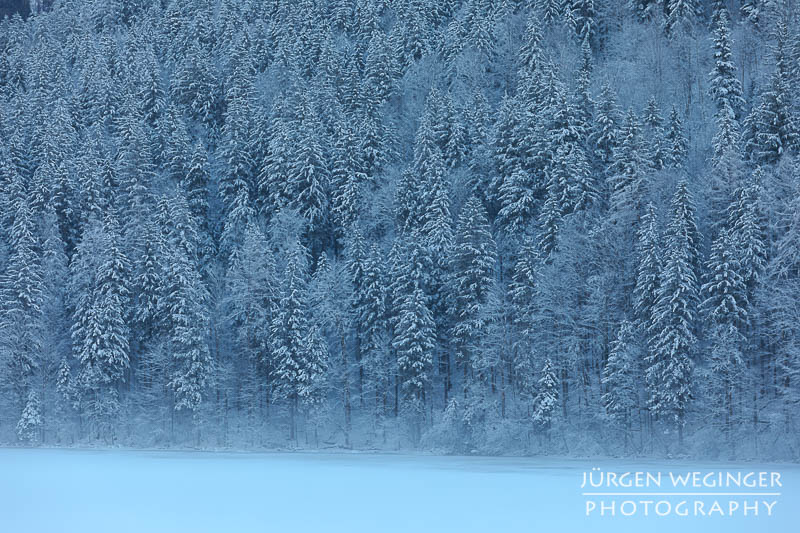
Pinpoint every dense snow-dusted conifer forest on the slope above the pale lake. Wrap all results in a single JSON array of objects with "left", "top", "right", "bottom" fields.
[{"left": 0, "top": 0, "right": 800, "bottom": 459}]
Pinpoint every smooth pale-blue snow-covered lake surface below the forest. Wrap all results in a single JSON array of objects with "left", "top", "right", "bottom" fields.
[{"left": 0, "top": 449, "right": 800, "bottom": 533}]
